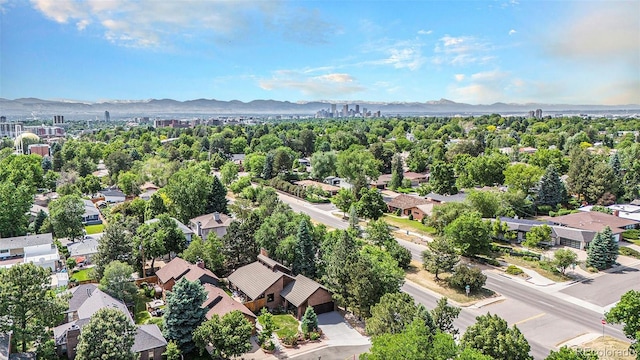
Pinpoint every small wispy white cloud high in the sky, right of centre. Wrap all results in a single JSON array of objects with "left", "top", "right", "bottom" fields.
[{"left": 432, "top": 35, "right": 493, "bottom": 66}]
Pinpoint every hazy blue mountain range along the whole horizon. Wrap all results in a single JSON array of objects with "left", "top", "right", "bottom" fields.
[{"left": 0, "top": 98, "right": 640, "bottom": 118}]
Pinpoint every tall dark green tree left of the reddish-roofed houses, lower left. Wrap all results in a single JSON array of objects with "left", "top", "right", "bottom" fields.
[{"left": 93, "top": 221, "right": 133, "bottom": 279}]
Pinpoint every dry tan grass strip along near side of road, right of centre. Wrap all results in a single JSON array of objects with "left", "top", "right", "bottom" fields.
[{"left": 406, "top": 260, "right": 495, "bottom": 304}]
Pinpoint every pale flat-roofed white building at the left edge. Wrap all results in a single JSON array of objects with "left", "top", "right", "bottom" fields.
[{"left": 0, "top": 233, "right": 60, "bottom": 271}]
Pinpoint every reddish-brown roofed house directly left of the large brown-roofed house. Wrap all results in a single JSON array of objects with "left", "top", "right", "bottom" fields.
[{"left": 156, "top": 257, "right": 220, "bottom": 291}]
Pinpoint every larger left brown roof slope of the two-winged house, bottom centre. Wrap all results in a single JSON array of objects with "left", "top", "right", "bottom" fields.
[{"left": 227, "top": 261, "right": 289, "bottom": 300}]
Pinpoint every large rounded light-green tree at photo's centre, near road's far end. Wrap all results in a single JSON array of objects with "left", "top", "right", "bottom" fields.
[{"left": 336, "top": 146, "right": 380, "bottom": 194}]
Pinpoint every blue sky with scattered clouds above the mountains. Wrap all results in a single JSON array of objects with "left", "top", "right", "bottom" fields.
[{"left": 0, "top": 0, "right": 640, "bottom": 104}]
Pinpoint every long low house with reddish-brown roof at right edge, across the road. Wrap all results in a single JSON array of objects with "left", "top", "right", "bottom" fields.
[{"left": 548, "top": 211, "right": 640, "bottom": 241}]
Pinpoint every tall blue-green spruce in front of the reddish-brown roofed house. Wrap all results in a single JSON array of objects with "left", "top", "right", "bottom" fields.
[{"left": 162, "top": 278, "right": 207, "bottom": 354}]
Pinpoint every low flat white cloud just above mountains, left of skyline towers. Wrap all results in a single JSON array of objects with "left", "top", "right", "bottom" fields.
[{"left": 258, "top": 70, "right": 366, "bottom": 98}]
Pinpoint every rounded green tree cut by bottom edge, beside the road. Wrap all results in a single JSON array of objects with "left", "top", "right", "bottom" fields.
[{"left": 460, "top": 314, "right": 533, "bottom": 360}]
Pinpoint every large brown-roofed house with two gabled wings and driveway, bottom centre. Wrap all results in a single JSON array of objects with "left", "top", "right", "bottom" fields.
[{"left": 227, "top": 254, "right": 335, "bottom": 319}]
